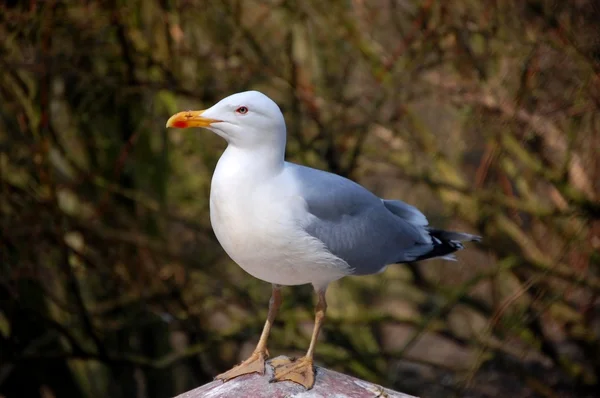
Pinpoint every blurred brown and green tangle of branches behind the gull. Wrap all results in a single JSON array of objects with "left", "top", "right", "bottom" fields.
[{"left": 0, "top": 0, "right": 600, "bottom": 398}]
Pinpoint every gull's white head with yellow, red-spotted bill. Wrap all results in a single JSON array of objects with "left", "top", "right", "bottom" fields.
[{"left": 167, "top": 91, "right": 286, "bottom": 149}]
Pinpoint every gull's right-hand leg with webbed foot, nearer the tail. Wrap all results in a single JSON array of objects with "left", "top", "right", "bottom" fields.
[{"left": 271, "top": 289, "right": 327, "bottom": 390}]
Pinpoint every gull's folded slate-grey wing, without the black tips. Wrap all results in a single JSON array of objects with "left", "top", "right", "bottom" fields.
[{"left": 289, "top": 164, "right": 432, "bottom": 275}]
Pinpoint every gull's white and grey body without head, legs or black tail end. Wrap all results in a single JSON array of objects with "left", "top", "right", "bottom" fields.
[{"left": 210, "top": 143, "right": 470, "bottom": 288}]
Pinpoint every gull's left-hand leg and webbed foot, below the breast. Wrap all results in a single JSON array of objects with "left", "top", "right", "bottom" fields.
[{"left": 215, "top": 284, "right": 281, "bottom": 382}]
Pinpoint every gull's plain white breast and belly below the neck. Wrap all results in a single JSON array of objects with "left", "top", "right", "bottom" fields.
[{"left": 210, "top": 160, "right": 350, "bottom": 286}]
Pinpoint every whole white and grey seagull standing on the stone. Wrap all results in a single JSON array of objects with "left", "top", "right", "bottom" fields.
[{"left": 167, "top": 91, "right": 480, "bottom": 389}]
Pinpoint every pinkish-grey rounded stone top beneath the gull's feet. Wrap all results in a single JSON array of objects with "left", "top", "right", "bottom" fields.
[{"left": 177, "top": 361, "right": 416, "bottom": 398}]
